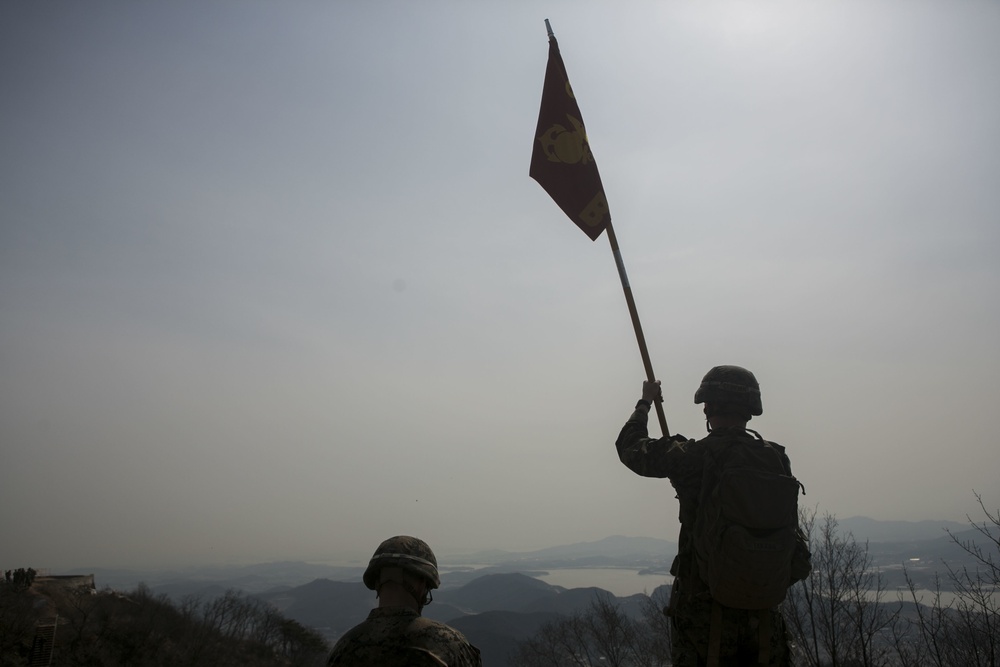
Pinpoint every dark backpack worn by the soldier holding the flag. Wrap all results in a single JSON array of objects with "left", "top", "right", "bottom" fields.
[{"left": 693, "top": 431, "right": 805, "bottom": 609}]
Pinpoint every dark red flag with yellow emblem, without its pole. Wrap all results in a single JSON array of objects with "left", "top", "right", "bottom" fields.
[{"left": 528, "top": 30, "right": 611, "bottom": 241}]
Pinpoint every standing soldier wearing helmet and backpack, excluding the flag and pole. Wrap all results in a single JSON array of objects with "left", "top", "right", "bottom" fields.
[{"left": 615, "top": 366, "right": 810, "bottom": 667}]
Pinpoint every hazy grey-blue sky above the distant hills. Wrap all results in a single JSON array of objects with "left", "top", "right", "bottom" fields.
[{"left": 0, "top": 0, "right": 1000, "bottom": 568}]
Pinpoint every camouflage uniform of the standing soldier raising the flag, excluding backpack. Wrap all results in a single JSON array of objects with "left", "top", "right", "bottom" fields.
[{"left": 615, "top": 409, "right": 790, "bottom": 667}]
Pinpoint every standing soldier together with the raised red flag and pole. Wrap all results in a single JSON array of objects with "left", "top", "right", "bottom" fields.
[{"left": 529, "top": 20, "right": 810, "bottom": 667}]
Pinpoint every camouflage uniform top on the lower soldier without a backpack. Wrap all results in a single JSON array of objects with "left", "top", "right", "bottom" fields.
[{"left": 327, "top": 607, "right": 482, "bottom": 667}]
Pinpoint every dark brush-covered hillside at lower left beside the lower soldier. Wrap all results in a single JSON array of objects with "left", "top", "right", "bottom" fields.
[{"left": 0, "top": 577, "right": 329, "bottom": 667}]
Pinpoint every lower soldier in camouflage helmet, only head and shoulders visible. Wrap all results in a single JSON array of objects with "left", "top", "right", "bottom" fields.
[{"left": 327, "top": 535, "right": 482, "bottom": 667}]
